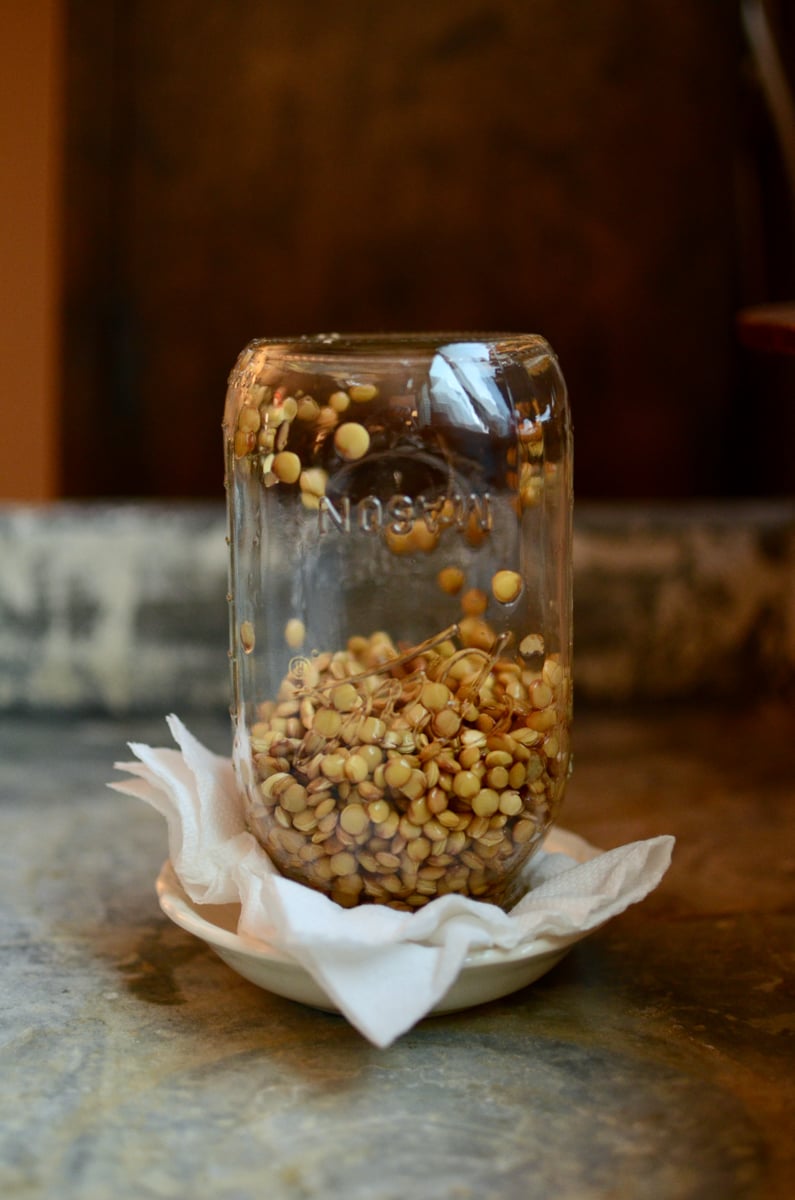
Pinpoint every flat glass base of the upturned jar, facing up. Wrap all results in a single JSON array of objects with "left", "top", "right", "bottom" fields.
[{"left": 247, "top": 330, "right": 551, "bottom": 365}]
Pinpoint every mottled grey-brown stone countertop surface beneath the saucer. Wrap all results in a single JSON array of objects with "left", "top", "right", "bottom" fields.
[{"left": 0, "top": 706, "right": 795, "bottom": 1200}]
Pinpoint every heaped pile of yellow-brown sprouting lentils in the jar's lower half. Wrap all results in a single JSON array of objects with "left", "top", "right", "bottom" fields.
[{"left": 247, "top": 625, "right": 570, "bottom": 911}]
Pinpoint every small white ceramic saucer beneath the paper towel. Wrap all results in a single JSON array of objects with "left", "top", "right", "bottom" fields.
[{"left": 156, "top": 829, "right": 600, "bottom": 1013}]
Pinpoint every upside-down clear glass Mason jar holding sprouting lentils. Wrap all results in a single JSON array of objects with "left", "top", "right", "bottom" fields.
[{"left": 223, "top": 334, "right": 572, "bottom": 910}]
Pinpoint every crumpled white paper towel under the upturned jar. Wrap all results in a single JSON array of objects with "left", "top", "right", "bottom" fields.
[{"left": 109, "top": 716, "right": 674, "bottom": 1046}]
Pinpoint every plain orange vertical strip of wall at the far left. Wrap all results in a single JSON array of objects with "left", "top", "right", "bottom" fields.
[{"left": 0, "top": 0, "right": 64, "bottom": 500}]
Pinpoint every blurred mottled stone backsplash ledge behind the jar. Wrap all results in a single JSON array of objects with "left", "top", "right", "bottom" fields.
[{"left": 0, "top": 500, "right": 795, "bottom": 714}]
